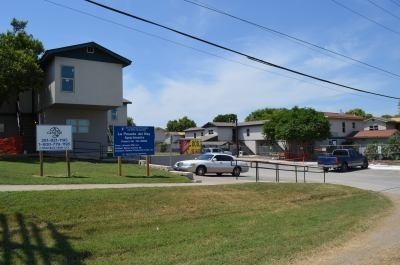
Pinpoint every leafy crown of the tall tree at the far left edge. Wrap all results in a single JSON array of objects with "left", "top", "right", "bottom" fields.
[{"left": 0, "top": 18, "right": 44, "bottom": 106}]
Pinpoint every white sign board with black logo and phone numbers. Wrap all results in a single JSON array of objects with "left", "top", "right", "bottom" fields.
[{"left": 36, "top": 125, "right": 72, "bottom": 151}]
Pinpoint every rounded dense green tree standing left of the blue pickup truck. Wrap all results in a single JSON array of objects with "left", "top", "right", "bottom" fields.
[{"left": 263, "top": 107, "right": 330, "bottom": 152}]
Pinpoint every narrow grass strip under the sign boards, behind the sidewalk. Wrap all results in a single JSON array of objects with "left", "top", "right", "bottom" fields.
[{"left": 0, "top": 156, "right": 189, "bottom": 185}]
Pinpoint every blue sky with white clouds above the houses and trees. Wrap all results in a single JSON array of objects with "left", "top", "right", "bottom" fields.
[{"left": 0, "top": 0, "right": 400, "bottom": 127}]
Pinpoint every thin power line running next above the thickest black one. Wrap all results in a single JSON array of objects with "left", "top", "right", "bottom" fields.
[{"left": 183, "top": 0, "right": 400, "bottom": 77}]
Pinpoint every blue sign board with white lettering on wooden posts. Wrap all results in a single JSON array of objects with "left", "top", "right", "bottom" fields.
[{"left": 114, "top": 126, "right": 154, "bottom": 156}]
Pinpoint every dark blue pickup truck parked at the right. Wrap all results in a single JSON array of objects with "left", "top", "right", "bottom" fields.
[{"left": 318, "top": 149, "right": 368, "bottom": 172}]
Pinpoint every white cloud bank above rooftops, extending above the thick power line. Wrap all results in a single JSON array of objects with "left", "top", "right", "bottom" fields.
[{"left": 124, "top": 27, "right": 398, "bottom": 127}]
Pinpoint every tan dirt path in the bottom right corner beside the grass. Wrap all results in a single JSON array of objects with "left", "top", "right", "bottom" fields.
[{"left": 292, "top": 193, "right": 400, "bottom": 265}]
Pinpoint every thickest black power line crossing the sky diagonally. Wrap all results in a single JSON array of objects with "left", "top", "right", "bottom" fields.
[{"left": 84, "top": 0, "right": 400, "bottom": 99}]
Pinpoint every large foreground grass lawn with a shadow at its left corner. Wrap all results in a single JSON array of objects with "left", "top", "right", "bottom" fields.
[{"left": 0, "top": 183, "right": 390, "bottom": 265}]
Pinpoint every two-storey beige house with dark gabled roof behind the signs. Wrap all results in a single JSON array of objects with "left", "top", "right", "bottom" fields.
[{"left": 0, "top": 42, "right": 131, "bottom": 155}]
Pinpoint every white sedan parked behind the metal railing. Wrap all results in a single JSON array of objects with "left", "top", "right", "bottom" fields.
[{"left": 173, "top": 153, "right": 249, "bottom": 176}]
